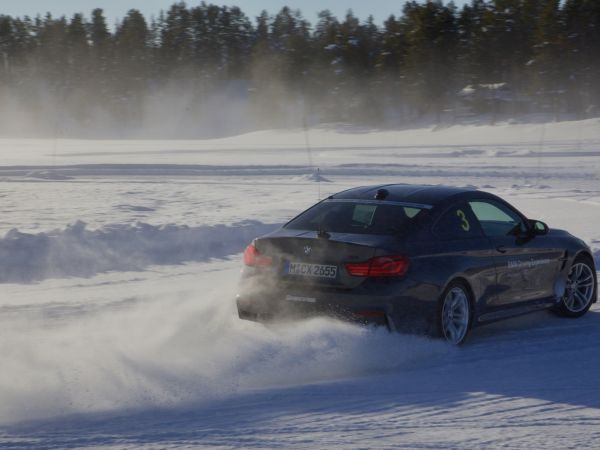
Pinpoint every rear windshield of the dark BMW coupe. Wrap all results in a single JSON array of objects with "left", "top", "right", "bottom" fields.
[{"left": 284, "top": 200, "right": 424, "bottom": 235}]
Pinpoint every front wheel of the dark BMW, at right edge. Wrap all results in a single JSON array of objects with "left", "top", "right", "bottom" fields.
[{"left": 553, "top": 255, "right": 598, "bottom": 318}]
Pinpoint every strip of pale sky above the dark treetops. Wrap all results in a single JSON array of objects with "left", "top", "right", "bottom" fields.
[{"left": 0, "top": 0, "right": 466, "bottom": 25}]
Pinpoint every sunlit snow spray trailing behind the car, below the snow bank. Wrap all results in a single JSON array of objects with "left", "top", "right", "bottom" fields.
[{"left": 0, "top": 261, "right": 453, "bottom": 423}]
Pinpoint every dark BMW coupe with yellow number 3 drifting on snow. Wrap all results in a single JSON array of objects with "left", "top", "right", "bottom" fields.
[{"left": 237, "top": 184, "right": 597, "bottom": 344}]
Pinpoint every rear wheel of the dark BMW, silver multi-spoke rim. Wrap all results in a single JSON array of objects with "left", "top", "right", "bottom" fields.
[{"left": 436, "top": 280, "right": 473, "bottom": 345}]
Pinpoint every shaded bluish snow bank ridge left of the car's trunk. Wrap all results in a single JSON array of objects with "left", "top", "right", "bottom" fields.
[{"left": 0, "top": 221, "right": 277, "bottom": 283}]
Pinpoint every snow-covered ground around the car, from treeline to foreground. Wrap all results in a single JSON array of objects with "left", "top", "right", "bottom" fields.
[{"left": 0, "top": 119, "right": 600, "bottom": 449}]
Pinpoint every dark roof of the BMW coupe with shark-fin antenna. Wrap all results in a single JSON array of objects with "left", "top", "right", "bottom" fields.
[{"left": 330, "top": 184, "right": 495, "bottom": 206}]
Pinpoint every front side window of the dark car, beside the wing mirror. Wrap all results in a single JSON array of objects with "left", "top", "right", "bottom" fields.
[{"left": 469, "top": 200, "right": 525, "bottom": 237}]
